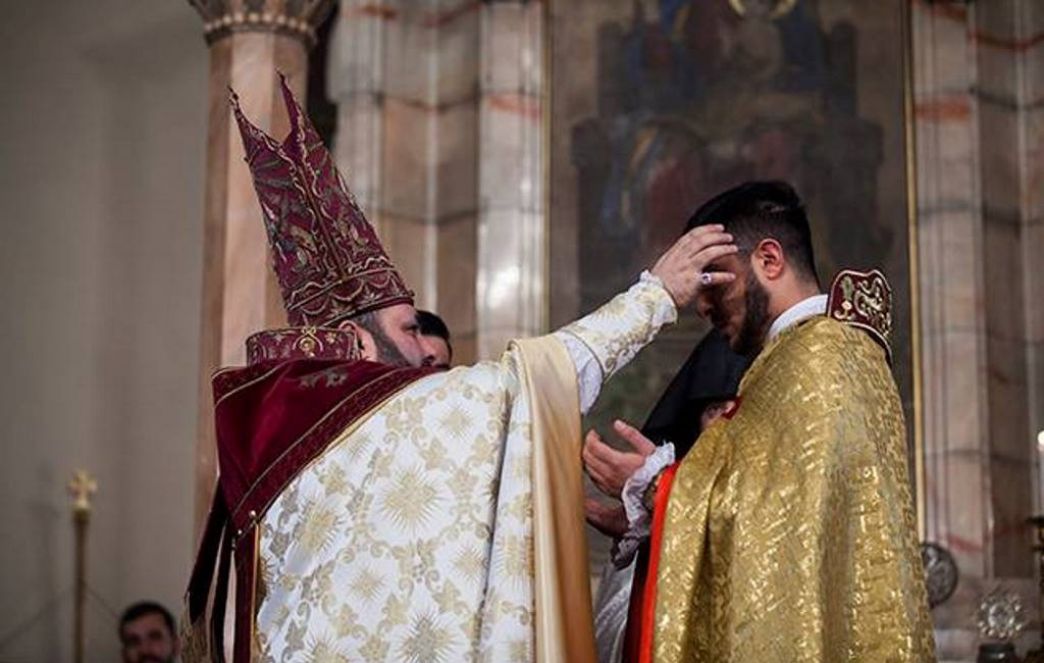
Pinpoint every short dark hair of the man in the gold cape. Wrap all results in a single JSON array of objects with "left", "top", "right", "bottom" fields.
[{"left": 685, "top": 182, "right": 820, "bottom": 284}]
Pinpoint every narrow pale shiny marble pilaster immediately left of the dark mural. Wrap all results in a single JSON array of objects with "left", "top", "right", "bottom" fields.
[{"left": 476, "top": 0, "right": 549, "bottom": 358}]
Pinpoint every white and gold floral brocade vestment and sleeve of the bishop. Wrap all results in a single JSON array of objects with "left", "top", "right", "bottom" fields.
[{"left": 257, "top": 282, "right": 674, "bottom": 663}]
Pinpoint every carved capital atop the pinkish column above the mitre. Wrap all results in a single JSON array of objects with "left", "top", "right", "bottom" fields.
[{"left": 188, "top": 0, "right": 334, "bottom": 47}]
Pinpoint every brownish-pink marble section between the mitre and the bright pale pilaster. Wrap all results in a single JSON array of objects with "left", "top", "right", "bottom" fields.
[{"left": 327, "top": 0, "right": 482, "bottom": 363}]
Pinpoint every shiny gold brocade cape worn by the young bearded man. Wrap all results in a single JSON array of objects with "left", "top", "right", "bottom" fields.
[{"left": 646, "top": 279, "right": 934, "bottom": 663}]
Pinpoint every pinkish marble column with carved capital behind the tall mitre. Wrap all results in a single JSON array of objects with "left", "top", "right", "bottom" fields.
[{"left": 189, "top": 0, "right": 333, "bottom": 532}]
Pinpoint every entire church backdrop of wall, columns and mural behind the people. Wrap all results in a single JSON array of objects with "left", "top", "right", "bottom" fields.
[{"left": 0, "top": 0, "right": 1044, "bottom": 662}]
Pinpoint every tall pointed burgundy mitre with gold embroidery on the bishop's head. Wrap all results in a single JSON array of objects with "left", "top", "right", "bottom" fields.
[{"left": 231, "top": 74, "right": 413, "bottom": 328}]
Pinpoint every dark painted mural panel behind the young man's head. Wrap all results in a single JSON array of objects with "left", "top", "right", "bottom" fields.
[{"left": 550, "top": 0, "right": 914, "bottom": 551}]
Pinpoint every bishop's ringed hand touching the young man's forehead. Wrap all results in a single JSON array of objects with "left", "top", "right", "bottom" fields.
[{"left": 650, "top": 224, "right": 739, "bottom": 309}]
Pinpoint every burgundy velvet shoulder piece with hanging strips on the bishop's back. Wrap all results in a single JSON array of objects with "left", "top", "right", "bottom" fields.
[{"left": 187, "top": 359, "right": 438, "bottom": 663}]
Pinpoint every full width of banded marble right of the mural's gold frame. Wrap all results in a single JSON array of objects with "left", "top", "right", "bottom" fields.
[{"left": 912, "top": 0, "right": 1044, "bottom": 661}]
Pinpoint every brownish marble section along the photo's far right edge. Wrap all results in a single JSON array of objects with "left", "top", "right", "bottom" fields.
[{"left": 972, "top": 0, "right": 1044, "bottom": 578}]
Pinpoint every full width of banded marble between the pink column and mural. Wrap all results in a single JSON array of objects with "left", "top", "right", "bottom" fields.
[{"left": 328, "top": 0, "right": 547, "bottom": 363}]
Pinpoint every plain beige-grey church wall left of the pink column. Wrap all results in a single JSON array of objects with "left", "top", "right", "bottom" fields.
[{"left": 0, "top": 0, "right": 207, "bottom": 662}]
